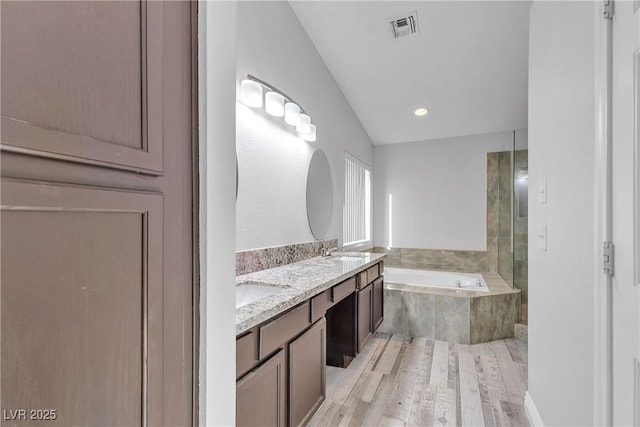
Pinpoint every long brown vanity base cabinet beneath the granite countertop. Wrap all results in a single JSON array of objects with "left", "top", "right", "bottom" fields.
[{"left": 236, "top": 263, "right": 383, "bottom": 426}]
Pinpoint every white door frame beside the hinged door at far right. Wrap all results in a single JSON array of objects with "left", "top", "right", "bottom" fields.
[{"left": 593, "top": 0, "right": 613, "bottom": 425}]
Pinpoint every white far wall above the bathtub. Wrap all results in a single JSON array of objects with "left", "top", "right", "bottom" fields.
[{"left": 374, "top": 130, "right": 527, "bottom": 250}]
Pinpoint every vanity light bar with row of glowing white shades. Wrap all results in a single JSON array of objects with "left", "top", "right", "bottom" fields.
[{"left": 240, "top": 74, "right": 316, "bottom": 142}]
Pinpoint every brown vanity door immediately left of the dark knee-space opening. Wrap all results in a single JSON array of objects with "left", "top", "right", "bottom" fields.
[{"left": 289, "top": 319, "right": 327, "bottom": 426}]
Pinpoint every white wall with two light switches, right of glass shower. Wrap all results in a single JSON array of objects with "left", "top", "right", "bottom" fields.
[{"left": 529, "top": 1, "right": 602, "bottom": 425}]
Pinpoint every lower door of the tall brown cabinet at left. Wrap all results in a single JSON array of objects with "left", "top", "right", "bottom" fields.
[{"left": 0, "top": 179, "right": 163, "bottom": 425}]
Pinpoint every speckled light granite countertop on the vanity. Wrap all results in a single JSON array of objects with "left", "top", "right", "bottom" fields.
[{"left": 236, "top": 252, "right": 386, "bottom": 335}]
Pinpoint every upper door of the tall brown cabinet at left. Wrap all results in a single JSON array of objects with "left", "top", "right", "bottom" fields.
[{"left": 1, "top": 1, "right": 163, "bottom": 174}]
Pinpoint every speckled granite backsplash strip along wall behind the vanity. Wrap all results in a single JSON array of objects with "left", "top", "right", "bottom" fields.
[{"left": 236, "top": 239, "right": 338, "bottom": 276}]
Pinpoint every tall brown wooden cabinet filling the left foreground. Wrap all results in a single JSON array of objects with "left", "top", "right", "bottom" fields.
[{"left": 0, "top": 1, "right": 199, "bottom": 426}]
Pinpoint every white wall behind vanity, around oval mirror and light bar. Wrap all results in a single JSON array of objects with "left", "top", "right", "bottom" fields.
[{"left": 236, "top": 1, "right": 373, "bottom": 250}]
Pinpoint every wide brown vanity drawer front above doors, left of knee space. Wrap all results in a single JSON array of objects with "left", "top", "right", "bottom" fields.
[{"left": 259, "top": 300, "right": 311, "bottom": 359}]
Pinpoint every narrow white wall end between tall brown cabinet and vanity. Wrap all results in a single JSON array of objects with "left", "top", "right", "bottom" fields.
[{"left": 198, "top": 2, "right": 236, "bottom": 426}]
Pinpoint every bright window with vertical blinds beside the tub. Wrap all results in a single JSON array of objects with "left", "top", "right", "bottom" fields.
[{"left": 342, "top": 153, "right": 371, "bottom": 246}]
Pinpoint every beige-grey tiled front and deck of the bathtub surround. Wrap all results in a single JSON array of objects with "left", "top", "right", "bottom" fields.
[{"left": 379, "top": 272, "right": 520, "bottom": 344}]
